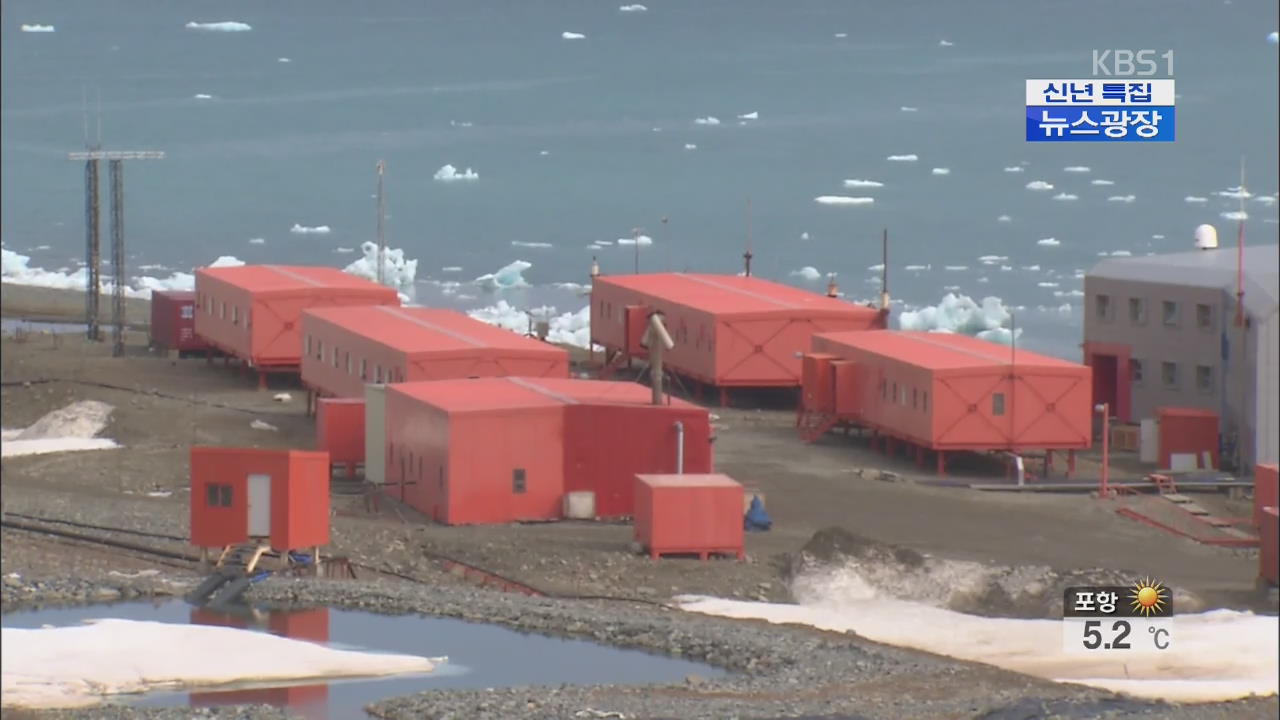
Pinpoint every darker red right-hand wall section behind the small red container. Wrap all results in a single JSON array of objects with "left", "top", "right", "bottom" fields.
[{"left": 563, "top": 404, "right": 712, "bottom": 518}]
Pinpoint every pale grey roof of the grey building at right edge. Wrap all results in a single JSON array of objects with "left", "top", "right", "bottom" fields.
[{"left": 1088, "top": 245, "right": 1280, "bottom": 316}]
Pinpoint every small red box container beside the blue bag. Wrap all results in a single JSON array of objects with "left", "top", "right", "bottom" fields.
[{"left": 635, "top": 474, "right": 744, "bottom": 560}]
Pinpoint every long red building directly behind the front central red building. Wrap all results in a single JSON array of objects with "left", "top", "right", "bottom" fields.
[{"left": 302, "top": 305, "right": 568, "bottom": 397}]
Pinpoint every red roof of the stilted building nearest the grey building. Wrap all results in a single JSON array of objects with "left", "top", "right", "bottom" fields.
[{"left": 814, "top": 331, "right": 1083, "bottom": 370}]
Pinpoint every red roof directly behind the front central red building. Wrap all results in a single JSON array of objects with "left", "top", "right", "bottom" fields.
[{"left": 303, "top": 305, "right": 567, "bottom": 356}]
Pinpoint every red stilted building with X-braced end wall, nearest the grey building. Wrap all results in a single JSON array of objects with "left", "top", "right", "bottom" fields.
[{"left": 801, "top": 331, "right": 1093, "bottom": 471}]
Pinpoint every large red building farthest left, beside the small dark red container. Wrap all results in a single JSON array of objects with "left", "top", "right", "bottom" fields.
[{"left": 196, "top": 265, "right": 399, "bottom": 373}]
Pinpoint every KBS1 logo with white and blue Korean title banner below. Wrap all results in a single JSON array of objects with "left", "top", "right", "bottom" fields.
[{"left": 1027, "top": 50, "right": 1176, "bottom": 142}]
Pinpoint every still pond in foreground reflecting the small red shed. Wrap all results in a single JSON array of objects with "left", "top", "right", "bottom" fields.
[{"left": 4, "top": 601, "right": 724, "bottom": 720}]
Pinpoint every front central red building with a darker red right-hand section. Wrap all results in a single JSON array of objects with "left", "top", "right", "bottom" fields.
[{"left": 385, "top": 378, "right": 716, "bottom": 525}]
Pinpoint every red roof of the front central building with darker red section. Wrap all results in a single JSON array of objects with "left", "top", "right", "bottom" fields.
[{"left": 388, "top": 377, "right": 698, "bottom": 413}]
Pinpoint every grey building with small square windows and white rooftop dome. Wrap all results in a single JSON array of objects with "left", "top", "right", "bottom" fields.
[{"left": 1083, "top": 245, "right": 1280, "bottom": 473}]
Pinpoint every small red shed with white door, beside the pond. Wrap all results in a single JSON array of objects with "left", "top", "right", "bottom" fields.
[{"left": 191, "top": 446, "right": 330, "bottom": 552}]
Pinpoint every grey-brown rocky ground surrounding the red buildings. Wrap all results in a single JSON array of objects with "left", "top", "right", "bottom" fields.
[{"left": 0, "top": 286, "right": 1280, "bottom": 720}]
